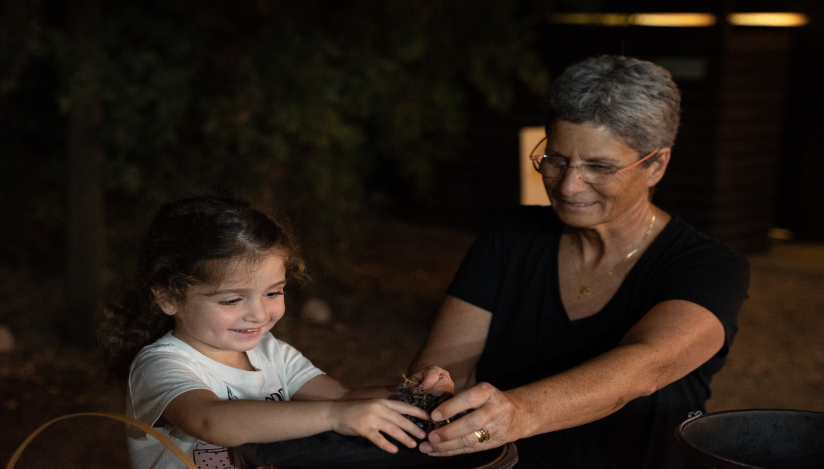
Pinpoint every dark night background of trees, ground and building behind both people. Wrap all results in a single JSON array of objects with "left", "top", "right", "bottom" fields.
[{"left": 0, "top": 0, "right": 824, "bottom": 468}]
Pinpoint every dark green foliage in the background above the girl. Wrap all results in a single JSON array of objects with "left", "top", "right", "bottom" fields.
[{"left": 0, "top": 0, "right": 546, "bottom": 342}]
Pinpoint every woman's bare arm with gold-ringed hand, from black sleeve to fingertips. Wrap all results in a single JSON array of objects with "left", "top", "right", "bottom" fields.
[{"left": 421, "top": 300, "right": 724, "bottom": 456}]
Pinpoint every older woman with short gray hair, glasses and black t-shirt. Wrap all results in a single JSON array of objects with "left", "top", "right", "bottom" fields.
[{"left": 412, "top": 56, "right": 749, "bottom": 468}]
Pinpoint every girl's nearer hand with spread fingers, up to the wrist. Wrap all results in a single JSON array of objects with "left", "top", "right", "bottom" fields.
[{"left": 327, "top": 399, "right": 429, "bottom": 453}]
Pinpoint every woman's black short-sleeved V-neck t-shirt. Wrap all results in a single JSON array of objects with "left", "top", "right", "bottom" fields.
[{"left": 448, "top": 206, "right": 749, "bottom": 469}]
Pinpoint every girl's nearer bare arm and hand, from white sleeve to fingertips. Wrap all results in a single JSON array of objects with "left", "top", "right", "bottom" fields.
[{"left": 163, "top": 384, "right": 429, "bottom": 453}]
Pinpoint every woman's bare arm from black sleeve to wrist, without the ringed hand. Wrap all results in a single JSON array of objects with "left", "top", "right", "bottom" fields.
[{"left": 486, "top": 300, "right": 724, "bottom": 435}]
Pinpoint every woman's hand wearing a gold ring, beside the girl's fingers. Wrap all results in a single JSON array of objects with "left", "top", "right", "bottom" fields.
[{"left": 420, "top": 383, "right": 525, "bottom": 456}]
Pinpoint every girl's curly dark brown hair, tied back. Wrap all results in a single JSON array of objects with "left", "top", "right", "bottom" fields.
[{"left": 99, "top": 195, "right": 308, "bottom": 380}]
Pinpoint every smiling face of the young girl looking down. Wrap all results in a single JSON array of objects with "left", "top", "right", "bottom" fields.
[{"left": 159, "top": 253, "right": 286, "bottom": 369}]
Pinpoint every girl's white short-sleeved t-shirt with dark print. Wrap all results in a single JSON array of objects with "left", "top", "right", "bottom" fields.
[{"left": 127, "top": 332, "right": 323, "bottom": 469}]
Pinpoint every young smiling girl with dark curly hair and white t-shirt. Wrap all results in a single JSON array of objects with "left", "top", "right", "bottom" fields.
[{"left": 104, "top": 196, "right": 453, "bottom": 469}]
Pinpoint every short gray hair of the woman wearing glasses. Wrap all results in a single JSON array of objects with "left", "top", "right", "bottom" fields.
[{"left": 546, "top": 55, "right": 681, "bottom": 154}]
